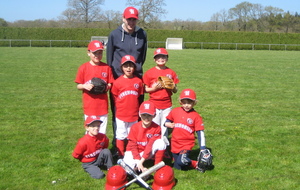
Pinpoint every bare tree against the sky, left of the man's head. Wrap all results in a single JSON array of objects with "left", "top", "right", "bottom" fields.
[{"left": 62, "top": 0, "right": 104, "bottom": 27}]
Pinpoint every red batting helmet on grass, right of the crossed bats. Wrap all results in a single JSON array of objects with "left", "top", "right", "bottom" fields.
[{"left": 152, "top": 165, "right": 175, "bottom": 190}]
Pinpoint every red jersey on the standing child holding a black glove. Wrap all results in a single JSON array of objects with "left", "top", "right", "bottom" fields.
[{"left": 75, "top": 62, "right": 114, "bottom": 115}]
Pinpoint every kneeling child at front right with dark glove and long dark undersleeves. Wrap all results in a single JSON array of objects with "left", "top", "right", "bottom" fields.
[{"left": 165, "top": 89, "right": 206, "bottom": 171}]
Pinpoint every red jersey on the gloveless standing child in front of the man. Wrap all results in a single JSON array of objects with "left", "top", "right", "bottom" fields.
[{"left": 111, "top": 75, "right": 144, "bottom": 122}]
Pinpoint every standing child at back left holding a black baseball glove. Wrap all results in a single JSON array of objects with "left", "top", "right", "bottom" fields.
[{"left": 75, "top": 40, "right": 114, "bottom": 134}]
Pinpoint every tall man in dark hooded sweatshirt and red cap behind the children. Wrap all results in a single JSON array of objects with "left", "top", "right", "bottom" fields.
[{"left": 106, "top": 7, "right": 147, "bottom": 153}]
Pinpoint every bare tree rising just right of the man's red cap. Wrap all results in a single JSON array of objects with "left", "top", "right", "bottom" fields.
[{"left": 127, "top": 0, "right": 167, "bottom": 28}]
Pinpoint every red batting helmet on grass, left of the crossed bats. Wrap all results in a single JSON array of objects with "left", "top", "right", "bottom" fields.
[{"left": 105, "top": 165, "right": 128, "bottom": 190}]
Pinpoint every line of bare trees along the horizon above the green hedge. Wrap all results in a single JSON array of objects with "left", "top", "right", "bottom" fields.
[{"left": 0, "top": 0, "right": 300, "bottom": 33}]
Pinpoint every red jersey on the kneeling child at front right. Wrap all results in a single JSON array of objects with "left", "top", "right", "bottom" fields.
[{"left": 167, "top": 107, "right": 204, "bottom": 153}]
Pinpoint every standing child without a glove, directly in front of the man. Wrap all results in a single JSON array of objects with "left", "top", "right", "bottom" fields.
[{"left": 111, "top": 55, "right": 144, "bottom": 158}]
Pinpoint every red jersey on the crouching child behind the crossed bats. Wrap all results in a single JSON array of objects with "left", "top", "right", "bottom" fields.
[{"left": 126, "top": 121, "right": 161, "bottom": 160}]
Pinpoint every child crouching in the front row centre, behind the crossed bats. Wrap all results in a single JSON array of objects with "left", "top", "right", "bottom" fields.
[{"left": 124, "top": 101, "right": 166, "bottom": 172}]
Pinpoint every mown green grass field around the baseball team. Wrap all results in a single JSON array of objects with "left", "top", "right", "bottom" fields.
[{"left": 0, "top": 48, "right": 300, "bottom": 190}]
